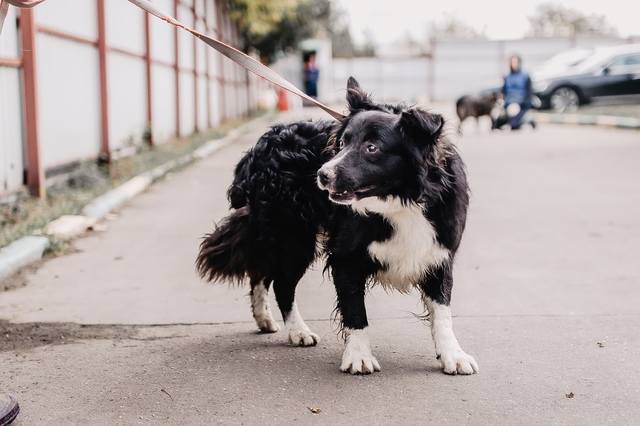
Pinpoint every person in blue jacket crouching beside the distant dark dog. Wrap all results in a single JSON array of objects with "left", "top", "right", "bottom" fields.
[{"left": 502, "top": 55, "right": 536, "bottom": 130}]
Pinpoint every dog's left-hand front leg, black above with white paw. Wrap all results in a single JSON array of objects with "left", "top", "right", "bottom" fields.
[{"left": 332, "top": 265, "right": 380, "bottom": 374}]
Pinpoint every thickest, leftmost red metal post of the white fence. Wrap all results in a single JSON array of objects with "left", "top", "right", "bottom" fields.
[{"left": 20, "top": 9, "right": 46, "bottom": 198}]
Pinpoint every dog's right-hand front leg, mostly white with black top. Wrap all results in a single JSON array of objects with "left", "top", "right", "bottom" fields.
[{"left": 420, "top": 262, "right": 479, "bottom": 374}]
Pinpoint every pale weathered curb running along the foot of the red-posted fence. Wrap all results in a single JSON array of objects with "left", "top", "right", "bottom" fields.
[{"left": 0, "top": 115, "right": 269, "bottom": 280}]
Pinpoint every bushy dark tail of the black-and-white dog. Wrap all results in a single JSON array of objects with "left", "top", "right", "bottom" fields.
[{"left": 196, "top": 206, "right": 268, "bottom": 283}]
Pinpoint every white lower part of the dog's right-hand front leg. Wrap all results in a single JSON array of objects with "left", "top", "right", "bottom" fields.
[{"left": 426, "top": 299, "right": 479, "bottom": 374}]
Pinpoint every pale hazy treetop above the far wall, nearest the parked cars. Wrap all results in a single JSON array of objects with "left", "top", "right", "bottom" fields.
[{"left": 528, "top": 3, "right": 616, "bottom": 37}]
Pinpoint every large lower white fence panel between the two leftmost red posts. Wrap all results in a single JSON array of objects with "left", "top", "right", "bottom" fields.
[{"left": 37, "top": 35, "right": 100, "bottom": 168}]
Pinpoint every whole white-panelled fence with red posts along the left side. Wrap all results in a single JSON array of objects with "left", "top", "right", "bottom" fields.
[{"left": 0, "top": 0, "right": 262, "bottom": 195}]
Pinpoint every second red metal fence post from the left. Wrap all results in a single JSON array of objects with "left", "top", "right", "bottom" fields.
[{"left": 96, "top": 0, "right": 111, "bottom": 161}]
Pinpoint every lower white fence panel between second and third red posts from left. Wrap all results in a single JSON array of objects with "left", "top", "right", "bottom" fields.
[{"left": 107, "top": 53, "right": 147, "bottom": 150}]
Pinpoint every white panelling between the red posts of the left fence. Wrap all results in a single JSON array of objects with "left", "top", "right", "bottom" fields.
[{"left": 0, "top": 0, "right": 258, "bottom": 195}]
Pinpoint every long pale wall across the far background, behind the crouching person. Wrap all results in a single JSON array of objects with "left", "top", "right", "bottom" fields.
[{"left": 302, "top": 37, "right": 632, "bottom": 103}]
